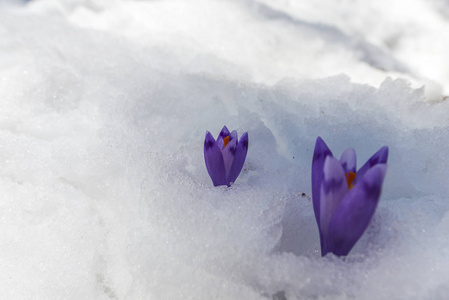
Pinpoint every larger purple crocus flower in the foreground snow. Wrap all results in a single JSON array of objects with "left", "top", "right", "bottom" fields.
[{"left": 312, "top": 137, "right": 388, "bottom": 256}]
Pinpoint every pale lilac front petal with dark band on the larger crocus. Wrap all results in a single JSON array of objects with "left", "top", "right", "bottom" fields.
[{"left": 320, "top": 156, "right": 349, "bottom": 243}]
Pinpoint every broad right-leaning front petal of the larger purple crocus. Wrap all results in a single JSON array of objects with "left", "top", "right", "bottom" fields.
[{"left": 327, "top": 164, "right": 387, "bottom": 256}]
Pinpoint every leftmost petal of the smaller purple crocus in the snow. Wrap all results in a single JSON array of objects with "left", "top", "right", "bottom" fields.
[{"left": 204, "top": 131, "right": 226, "bottom": 186}]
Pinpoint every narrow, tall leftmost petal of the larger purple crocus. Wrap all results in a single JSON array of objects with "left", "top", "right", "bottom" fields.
[{"left": 312, "top": 137, "right": 332, "bottom": 246}]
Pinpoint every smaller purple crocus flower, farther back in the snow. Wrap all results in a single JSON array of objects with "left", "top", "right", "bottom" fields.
[{"left": 204, "top": 126, "right": 248, "bottom": 186}]
